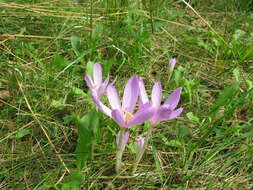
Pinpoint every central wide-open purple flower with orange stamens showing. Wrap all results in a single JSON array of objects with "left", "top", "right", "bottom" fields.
[{"left": 93, "top": 77, "right": 154, "bottom": 128}]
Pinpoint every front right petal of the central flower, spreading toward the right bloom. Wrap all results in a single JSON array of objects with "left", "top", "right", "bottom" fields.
[{"left": 127, "top": 102, "right": 155, "bottom": 127}]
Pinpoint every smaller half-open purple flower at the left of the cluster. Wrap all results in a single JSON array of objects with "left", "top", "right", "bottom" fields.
[{"left": 85, "top": 62, "right": 109, "bottom": 98}]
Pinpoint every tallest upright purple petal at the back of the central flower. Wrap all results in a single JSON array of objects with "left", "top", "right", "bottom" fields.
[{"left": 122, "top": 77, "right": 139, "bottom": 113}]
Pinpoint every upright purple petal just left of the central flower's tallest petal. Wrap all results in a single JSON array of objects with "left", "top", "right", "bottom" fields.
[{"left": 107, "top": 84, "right": 121, "bottom": 110}]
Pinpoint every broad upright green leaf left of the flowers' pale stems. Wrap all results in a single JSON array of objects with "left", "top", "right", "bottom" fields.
[{"left": 75, "top": 109, "right": 99, "bottom": 170}]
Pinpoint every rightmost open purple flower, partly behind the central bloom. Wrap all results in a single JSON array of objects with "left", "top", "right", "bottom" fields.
[{"left": 139, "top": 79, "right": 183, "bottom": 125}]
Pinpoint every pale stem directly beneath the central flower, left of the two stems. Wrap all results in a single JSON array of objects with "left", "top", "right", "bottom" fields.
[{"left": 116, "top": 128, "right": 126, "bottom": 174}]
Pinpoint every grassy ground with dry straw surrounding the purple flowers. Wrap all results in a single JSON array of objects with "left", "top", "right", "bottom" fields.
[{"left": 0, "top": 0, "right": 253, "bottom": 190}]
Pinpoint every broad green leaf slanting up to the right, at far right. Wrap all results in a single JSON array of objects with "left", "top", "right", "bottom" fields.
[{"left": 211, "top": 82, "right": 239, "bottom": 114}]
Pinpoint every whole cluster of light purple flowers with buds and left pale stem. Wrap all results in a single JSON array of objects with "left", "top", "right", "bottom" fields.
[{"left": 85, "top": 60, "right": 183, "bottom": 173}]
